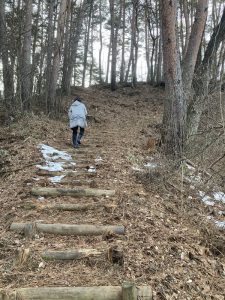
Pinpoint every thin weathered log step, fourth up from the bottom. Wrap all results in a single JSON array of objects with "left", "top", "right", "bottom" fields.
[{"left": 23, "top": 202, "right": 106, "bottom": 211}]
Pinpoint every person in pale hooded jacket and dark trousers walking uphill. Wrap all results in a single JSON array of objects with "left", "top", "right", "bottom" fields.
[{"left": 68, "top": 97, "right": 87, "bottom": 148}]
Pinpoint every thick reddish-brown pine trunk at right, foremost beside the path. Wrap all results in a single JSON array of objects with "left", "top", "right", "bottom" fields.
[{"left": 161, "top": 0, "right": 186, "bottom": 157}]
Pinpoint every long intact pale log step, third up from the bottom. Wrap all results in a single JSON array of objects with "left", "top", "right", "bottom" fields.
[{"left": 10, "top": 222, "right": 125, "bottom": 237}]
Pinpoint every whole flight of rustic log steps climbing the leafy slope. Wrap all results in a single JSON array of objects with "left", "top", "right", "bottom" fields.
[{"left": 0, "top": 132, "right": 153, "bottom": 300}]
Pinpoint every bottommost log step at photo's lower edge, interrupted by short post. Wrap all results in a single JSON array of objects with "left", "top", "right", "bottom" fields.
[{"left": 0, "top": 286, "right": 153, "bottom": 300}]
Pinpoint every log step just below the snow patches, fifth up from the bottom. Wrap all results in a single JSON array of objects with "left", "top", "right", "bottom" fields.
[{"left": 31, "top": 187, "right": 115, "bottom": 197}]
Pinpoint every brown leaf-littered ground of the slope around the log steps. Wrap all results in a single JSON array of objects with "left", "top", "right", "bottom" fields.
[{"left": 0, "top": 85, "right": 225, "bottom": 300}]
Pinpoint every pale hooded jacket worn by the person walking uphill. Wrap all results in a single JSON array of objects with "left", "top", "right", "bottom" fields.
[{"left": 68, "top": 100, "right": 87, "bottom": 128}]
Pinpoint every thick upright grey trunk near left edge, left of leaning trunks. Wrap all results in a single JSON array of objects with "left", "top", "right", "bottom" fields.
[{"left": 21, "top": 0, "right": 32, "bottom": 110}]
